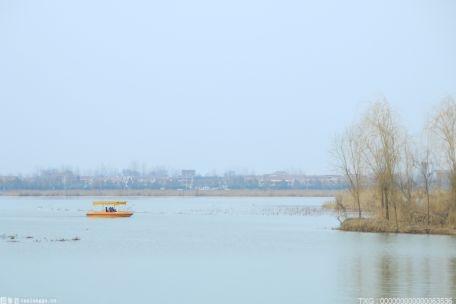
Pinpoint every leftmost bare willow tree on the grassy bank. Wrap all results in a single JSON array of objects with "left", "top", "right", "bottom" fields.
[{"left": 331, "top": 125, "right": 365, "bottom": 218}]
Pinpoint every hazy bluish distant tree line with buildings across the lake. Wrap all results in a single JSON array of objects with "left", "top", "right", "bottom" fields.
[{"left": 0, "top": 169, "right": 346, "bottom": 191}]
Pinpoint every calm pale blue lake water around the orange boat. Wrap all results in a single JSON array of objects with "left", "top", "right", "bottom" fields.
[{"left": 0, "top": 197, "right": 456, "bottom": 304}]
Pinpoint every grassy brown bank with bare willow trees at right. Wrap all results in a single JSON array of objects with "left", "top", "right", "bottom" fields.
[{"left": 332, "top": 97, "right": 456, "bottom": 235}]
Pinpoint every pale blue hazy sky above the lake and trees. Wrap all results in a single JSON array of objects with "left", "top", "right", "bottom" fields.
[{"left": 0, "top": 0, "right": 456, "bottom": 174}]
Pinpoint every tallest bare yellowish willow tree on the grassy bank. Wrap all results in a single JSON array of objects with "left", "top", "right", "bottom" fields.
[{"left": 362, "top": 100, "right": 403, "bottom": 228}]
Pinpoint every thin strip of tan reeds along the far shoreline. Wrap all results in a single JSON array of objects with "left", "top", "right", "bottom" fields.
[{"left": 0, "top": 189, "right": 341, "bottom": 197}]
